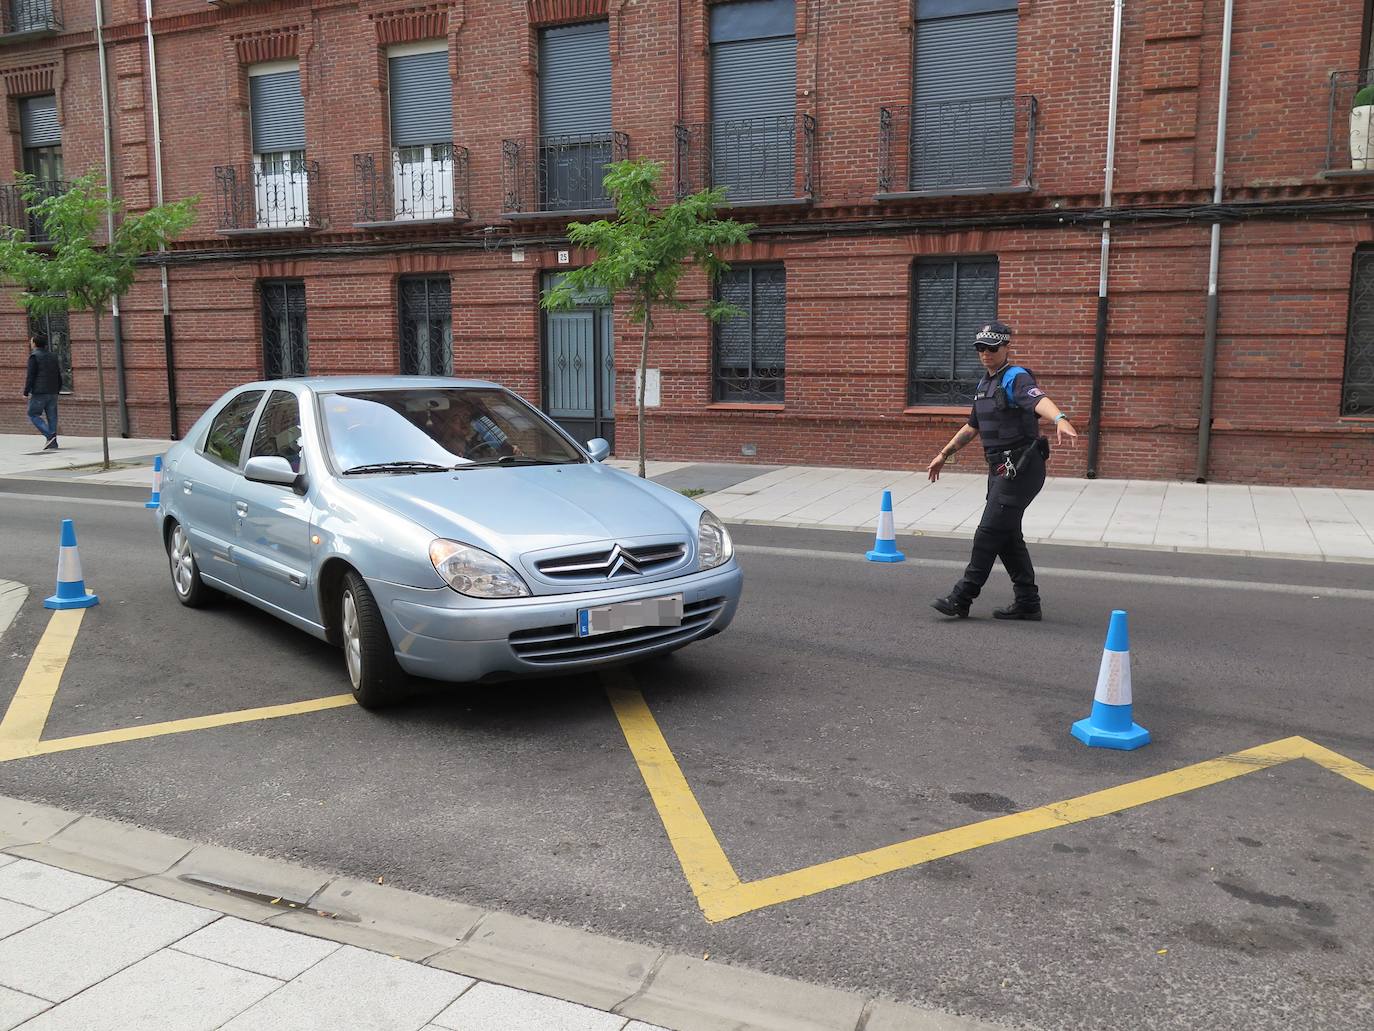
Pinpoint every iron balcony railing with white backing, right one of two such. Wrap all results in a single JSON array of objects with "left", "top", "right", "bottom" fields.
[{"left": 353, "top": 143, "right": 469, "bottom": 225}]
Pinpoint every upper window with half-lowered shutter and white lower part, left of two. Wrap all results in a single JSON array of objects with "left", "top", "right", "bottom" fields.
[{"left": 249, "top": 60, "right": 311, "bottom": 230}]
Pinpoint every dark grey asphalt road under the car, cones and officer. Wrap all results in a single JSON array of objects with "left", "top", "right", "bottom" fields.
[{"left": 0, "top": 481, "right": 1374, "bottom": 1031}]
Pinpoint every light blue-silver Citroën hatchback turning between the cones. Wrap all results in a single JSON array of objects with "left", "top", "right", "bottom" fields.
[{"left": 158, "top": 377, "right": 743, "bottom": 708}]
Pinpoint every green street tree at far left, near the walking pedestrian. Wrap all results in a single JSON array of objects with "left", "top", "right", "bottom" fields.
[{"left": 0, "top": 172, "right": 196, "bottom": 469}]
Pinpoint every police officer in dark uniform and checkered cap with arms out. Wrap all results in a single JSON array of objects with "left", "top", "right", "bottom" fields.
[{"left": 926, "top": 322, "right": 1079, "bottom": 620}]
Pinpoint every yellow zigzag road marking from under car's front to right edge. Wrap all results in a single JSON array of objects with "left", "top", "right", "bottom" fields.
[{"left": 607, "top": 686, "right": 1374, "bottom": 922}]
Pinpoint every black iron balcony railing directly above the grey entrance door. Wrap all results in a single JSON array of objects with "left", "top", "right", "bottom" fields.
[{"left": 502, "top": 132, "right": 629, "bottom": 214}]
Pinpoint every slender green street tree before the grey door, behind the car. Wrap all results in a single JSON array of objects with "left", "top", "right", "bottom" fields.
[{"left": 541, "top": 158, "right": 754, "bottom": 476}]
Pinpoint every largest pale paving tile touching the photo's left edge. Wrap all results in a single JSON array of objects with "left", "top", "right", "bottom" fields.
[{"left": 0, "top": 887, "right": 218, "bottom": 1002}]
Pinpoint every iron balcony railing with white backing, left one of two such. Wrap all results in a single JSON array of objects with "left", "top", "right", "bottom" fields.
[{"left": 214, "top": 154, "right": 320, "bottom": 232}]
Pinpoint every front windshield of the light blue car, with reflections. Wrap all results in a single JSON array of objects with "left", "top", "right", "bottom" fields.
[{"left": 320, "top": 388, "right": 585, "bottom": 476}]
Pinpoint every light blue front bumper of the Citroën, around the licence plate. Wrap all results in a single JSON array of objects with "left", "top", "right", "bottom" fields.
[{"left": 368, "top": 559, "right": 743, "bottom": 682}]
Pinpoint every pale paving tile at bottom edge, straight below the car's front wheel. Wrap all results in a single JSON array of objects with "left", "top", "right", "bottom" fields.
[{"left": 224, "top": 946, "right": 473, "bottom": 1031}]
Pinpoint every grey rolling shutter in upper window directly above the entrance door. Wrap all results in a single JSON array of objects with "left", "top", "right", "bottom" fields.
[{"left": 539, "top": 22, "right": 611, "bottom": 136}]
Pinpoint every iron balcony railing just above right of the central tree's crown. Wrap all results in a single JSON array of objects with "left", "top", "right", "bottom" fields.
[{"left": 676, "top": 114, "right": 816, "bottom": 205}]
